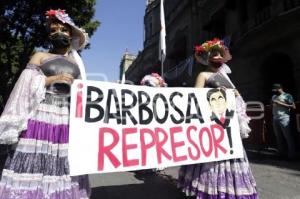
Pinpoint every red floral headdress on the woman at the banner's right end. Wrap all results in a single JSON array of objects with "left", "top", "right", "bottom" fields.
[{"left": 195, "top": 38, "right": 231, "bottom": 65}]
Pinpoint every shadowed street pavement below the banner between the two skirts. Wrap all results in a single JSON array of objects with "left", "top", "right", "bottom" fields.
[{"left": 90, "top": 168, "right": 184, "bottom": 199}]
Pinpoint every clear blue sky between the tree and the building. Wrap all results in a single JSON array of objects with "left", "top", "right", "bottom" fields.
[{"left": 82, "top": 0, "right": 146, "bottom": 81}]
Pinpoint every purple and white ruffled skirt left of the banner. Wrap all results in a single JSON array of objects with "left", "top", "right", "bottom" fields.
[{"left": 0, "top": 93, "right": 90, "bottom": 199}]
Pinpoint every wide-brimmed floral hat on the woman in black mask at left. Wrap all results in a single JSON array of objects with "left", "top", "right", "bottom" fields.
[{"left": 45, "top": 9, "right": 89, "bottom": 50}]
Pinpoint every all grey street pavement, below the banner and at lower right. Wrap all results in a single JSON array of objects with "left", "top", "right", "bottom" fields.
[{"left": 90, "top": 156, "right": 300, "bottom": 199}]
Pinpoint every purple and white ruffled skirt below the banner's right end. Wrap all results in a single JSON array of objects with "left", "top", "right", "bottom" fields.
[{"left": 178, "top": 153, "right": 258, "bottom": 199}]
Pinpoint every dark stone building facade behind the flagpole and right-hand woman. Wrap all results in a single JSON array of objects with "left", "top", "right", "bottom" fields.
[{"left": 126, "top": 0, "right": 300, "bottom": 104}]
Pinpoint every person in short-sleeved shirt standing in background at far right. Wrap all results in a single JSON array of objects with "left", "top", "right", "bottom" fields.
[{"left": 271, "top": 84, "right": 296, "bottom": 159}]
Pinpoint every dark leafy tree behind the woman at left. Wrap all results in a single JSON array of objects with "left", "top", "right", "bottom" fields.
[{"left": 0, "top": 0, "right": 100, "bottom": 112}]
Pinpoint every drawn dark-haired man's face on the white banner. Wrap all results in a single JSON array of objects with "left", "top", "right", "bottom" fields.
[{"left": 207, "top": 89, "right": 227, "bottom": 115}]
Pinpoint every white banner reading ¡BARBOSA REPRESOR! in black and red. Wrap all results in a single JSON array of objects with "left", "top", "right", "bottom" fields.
[{"left": 69, "top": 80, "right": 243, "bottom": 175}]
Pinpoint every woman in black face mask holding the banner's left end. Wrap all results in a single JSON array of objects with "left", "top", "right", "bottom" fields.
[{"left": 0, "top": 9, "right": 90, "bottom": 199}]
